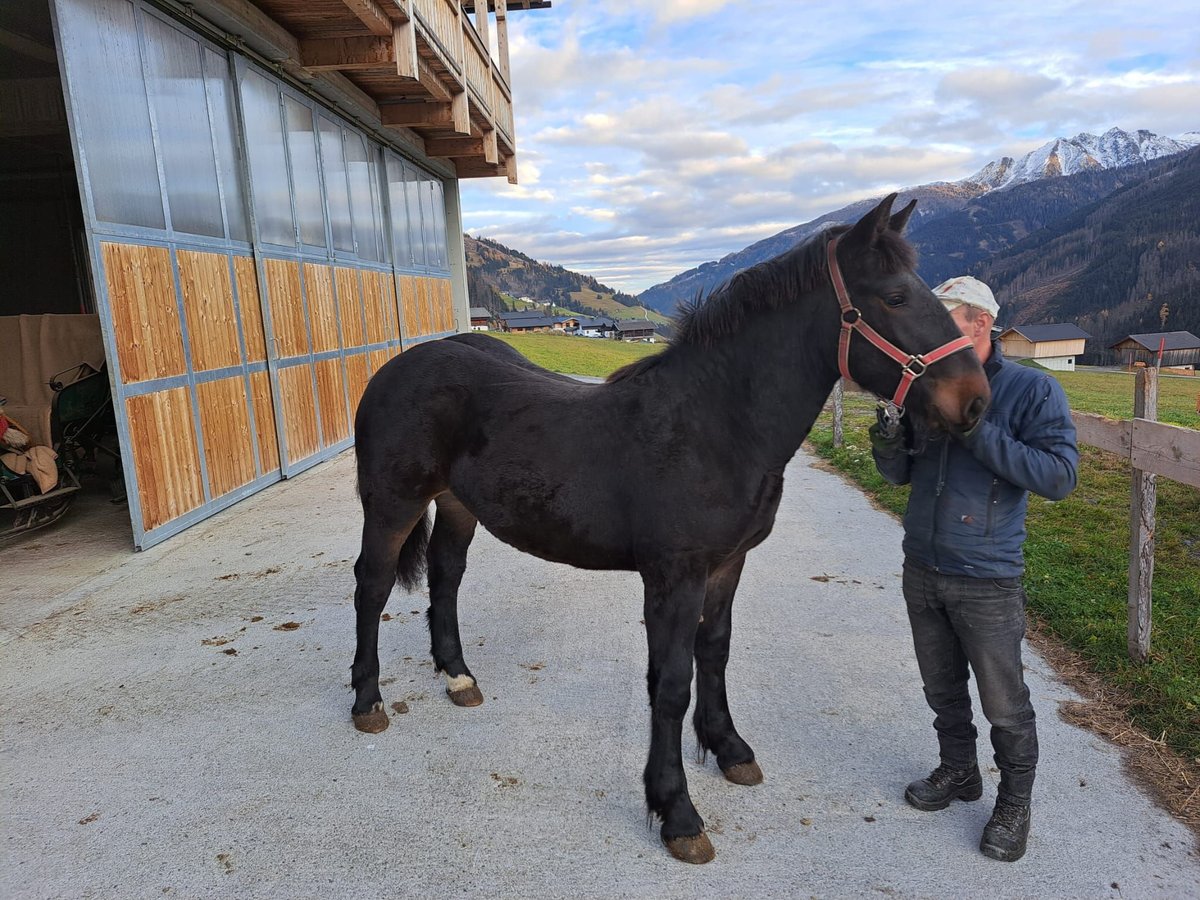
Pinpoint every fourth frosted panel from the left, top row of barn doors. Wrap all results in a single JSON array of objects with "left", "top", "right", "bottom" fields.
[{"left": 241, "top": 70, "right": 295, "bottom": 246}]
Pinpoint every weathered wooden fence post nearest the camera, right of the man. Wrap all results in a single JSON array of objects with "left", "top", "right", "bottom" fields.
[{"left": 1127, "top": 366, "right": 1158, "bottom": 662}]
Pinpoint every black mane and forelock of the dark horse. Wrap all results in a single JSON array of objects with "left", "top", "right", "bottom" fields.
[{"left": 608, "top": 226, "right": 917, "bottom": 382}]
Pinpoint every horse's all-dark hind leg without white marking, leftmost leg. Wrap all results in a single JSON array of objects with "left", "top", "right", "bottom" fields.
[{"left": 350, "top": 509, "right": 428, "bottom": 734}]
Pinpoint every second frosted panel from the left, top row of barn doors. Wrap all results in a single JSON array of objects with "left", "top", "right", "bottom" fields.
[{"left": 143, "top": 16, "right": 224, "bottom": 238}]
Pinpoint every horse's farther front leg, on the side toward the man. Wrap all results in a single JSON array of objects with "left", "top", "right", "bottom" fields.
[{"left": 692, "top": 556, "right": 762, "bottom": 785}]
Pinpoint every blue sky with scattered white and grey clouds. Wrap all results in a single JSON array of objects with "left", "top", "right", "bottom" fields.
[{"left": 462, "top": 0, "right": 1200, "bottom": 293}]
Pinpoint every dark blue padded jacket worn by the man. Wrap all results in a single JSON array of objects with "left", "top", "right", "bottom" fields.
[{"left": 874, "top": 341, "right": 1079, "bottom": 578}]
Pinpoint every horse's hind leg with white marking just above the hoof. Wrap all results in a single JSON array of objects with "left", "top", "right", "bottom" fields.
[{"left": 428, "top": 492, "right": 484, "bottom": 707}]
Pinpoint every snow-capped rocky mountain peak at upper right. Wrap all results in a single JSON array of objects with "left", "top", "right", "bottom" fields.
[{"left": 962, "top": 128, "right": 1200, "bottom": 191}]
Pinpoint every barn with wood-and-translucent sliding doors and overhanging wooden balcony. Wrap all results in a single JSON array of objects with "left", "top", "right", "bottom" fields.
[{"left": 0, "top": 0, "right": 550, "bottom": 548}]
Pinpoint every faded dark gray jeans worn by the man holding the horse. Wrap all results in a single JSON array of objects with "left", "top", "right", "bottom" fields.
[{"left": 904, "top": 559, "right": 1038, "bottom": 803}]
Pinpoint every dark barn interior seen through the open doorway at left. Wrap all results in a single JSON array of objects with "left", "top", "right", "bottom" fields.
[{"left": 0, "top": 0, "right": 128, "bottom": 540}]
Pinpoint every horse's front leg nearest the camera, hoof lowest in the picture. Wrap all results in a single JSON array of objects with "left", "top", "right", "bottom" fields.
[{"left": 642, "top": 562, "right": 715, "bottom": 863}]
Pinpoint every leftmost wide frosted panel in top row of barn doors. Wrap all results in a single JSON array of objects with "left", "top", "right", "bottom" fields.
[{"left": 58, "top": 0, "right": 166, "bottom": 228}]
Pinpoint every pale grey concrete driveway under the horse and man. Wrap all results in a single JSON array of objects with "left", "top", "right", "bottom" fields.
[{"left": 0, "top": 452, "right": 1200, "bottom": 899}]
